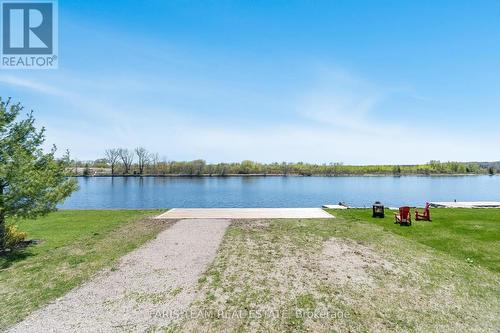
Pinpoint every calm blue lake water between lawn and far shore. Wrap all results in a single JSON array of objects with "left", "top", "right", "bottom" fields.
[{"left": 61, "top": 176, "right": 500, "bottom": 209}]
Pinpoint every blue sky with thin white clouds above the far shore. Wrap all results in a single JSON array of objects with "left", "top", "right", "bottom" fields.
[{"left": 0, "top": 0, "right": 500, "bottom": 164}]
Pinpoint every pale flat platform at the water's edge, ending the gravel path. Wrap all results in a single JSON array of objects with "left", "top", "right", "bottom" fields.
[{"left": 156, "top": 208, "right": 334, "bottom": 219}]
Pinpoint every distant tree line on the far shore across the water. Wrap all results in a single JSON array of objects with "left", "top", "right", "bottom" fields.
[{"left": 67, "top": 147, "right": 500, "bottom": 176}]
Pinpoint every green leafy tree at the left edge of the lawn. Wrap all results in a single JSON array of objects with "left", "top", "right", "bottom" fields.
[{"left": 0, "top": 98, "right": 77, "bottom": 252}]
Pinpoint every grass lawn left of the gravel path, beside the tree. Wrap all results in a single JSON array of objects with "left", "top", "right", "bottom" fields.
[{"left": 0, "top": 210, "right": 165, "bottom": 331}]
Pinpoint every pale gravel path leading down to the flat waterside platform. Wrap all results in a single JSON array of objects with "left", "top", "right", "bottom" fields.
[{"left": 9, "top": 219, "right": 229, "bottom": 332}]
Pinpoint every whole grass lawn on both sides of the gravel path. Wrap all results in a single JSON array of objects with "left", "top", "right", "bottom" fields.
[{"left": 0, "top": 209, "right": 500, "bottom": 333}]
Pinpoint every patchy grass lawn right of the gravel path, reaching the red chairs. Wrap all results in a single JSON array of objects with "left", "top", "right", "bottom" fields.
[{"left": 173, "top": 209, "right": 500, "bottom": 332}]
